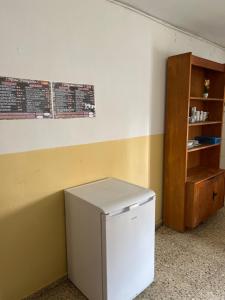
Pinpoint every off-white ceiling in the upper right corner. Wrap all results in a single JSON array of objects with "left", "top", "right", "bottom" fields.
[{"left": 117, "top": 0, "right": 225, "bottom": 48}]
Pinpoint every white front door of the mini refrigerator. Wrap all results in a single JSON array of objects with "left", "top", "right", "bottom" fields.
[{"left": 102, "top": 197, "right": 155, "bottom": 300}]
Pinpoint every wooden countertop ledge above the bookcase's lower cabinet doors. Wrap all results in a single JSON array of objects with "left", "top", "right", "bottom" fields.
[{"left": 187, "top": 166, "right": 224, "bottom": 182}]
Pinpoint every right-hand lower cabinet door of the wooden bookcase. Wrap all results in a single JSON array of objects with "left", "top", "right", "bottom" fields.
[{"left": 212, "top": 174, "right": 225, "bottom": 213}]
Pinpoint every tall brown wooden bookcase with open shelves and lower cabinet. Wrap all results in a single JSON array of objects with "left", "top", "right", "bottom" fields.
[{"left": 163, "top": 53, "right": 225, "bottom": 232}]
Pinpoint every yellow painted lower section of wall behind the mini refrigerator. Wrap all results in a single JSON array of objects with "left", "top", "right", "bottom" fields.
[{"left": 0, "top": 135, "right": 163, "bottom": 300}]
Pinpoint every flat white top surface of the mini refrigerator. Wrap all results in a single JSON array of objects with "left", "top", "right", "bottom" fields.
[{"left": 65, "top": 178, "right": 155, "bottom": 214}]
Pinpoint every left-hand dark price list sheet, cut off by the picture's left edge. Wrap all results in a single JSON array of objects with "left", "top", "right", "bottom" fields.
[{"left": 0, "top": 77, "right": 52, "bottom": 120}]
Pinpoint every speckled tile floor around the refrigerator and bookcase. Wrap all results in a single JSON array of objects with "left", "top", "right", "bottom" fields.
[{"left": 26, "top": 209, "right": 225, "bottom": 300}]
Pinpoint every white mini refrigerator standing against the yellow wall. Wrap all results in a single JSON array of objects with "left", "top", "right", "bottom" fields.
[{"left": 65, "top": 178, "right": 155, "bottom": 300}]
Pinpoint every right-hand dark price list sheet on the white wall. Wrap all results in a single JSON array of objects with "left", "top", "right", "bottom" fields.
[{"left": 52, "top": 82, "right": 95, "bottom": 118}]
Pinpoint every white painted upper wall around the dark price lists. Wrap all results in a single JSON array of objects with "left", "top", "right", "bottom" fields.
[{"left": 0, "top": 0, "right": 225, "bottom": 153}]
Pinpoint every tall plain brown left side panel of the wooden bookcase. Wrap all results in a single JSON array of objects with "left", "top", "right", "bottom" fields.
[{"left": 163, "top": 53, "right": 191, "bottom": 231}]
